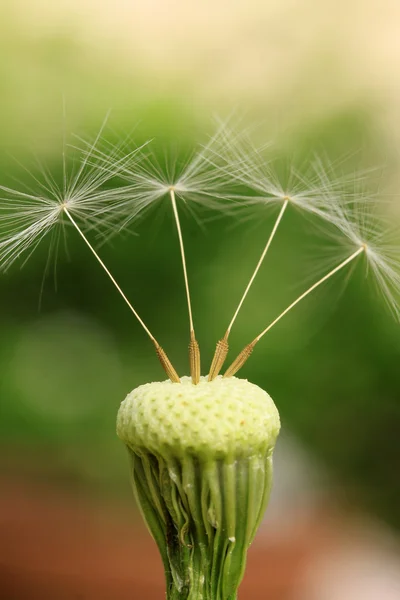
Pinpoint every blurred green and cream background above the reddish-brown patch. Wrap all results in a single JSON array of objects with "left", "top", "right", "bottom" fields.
[{"left": 0, "top": 0, "right": 400, "bottom": 596}]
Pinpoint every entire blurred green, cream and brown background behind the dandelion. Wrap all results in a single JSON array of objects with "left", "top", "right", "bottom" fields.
[{"left": 0, "top": 0, "right": 400, "bottom": 600}]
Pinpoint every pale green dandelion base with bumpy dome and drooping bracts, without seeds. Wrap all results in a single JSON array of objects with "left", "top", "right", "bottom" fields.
[{"left": 117, "top": 377, "right": 280, "bottom": 600}]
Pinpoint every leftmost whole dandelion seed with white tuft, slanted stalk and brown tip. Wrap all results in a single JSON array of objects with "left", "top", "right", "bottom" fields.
[{"left": 0, "top": 123, "right": 180, "bottom": 383}]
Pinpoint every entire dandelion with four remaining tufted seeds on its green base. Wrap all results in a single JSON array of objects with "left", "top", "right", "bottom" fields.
[{"left": 0, "top": 127, "right": 400, "bottom": 600}]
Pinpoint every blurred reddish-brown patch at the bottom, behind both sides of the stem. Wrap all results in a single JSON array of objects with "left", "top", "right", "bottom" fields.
[{"left": 0, "top": 479, "right": 324, "bottom": 600}]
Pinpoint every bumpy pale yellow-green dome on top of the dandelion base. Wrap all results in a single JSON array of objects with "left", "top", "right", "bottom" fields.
[{"left": 117, "top": 377, "right": 280, "bottom": 456}]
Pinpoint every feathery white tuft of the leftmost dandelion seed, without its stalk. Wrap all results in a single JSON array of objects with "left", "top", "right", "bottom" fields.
[{"left": 0, "top": 110, "right": 153, "bottom": 269}]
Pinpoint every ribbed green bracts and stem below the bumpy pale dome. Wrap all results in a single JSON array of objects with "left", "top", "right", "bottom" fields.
[{"left": 129, "top": 450, "right": 272, "bottom": 600}]
